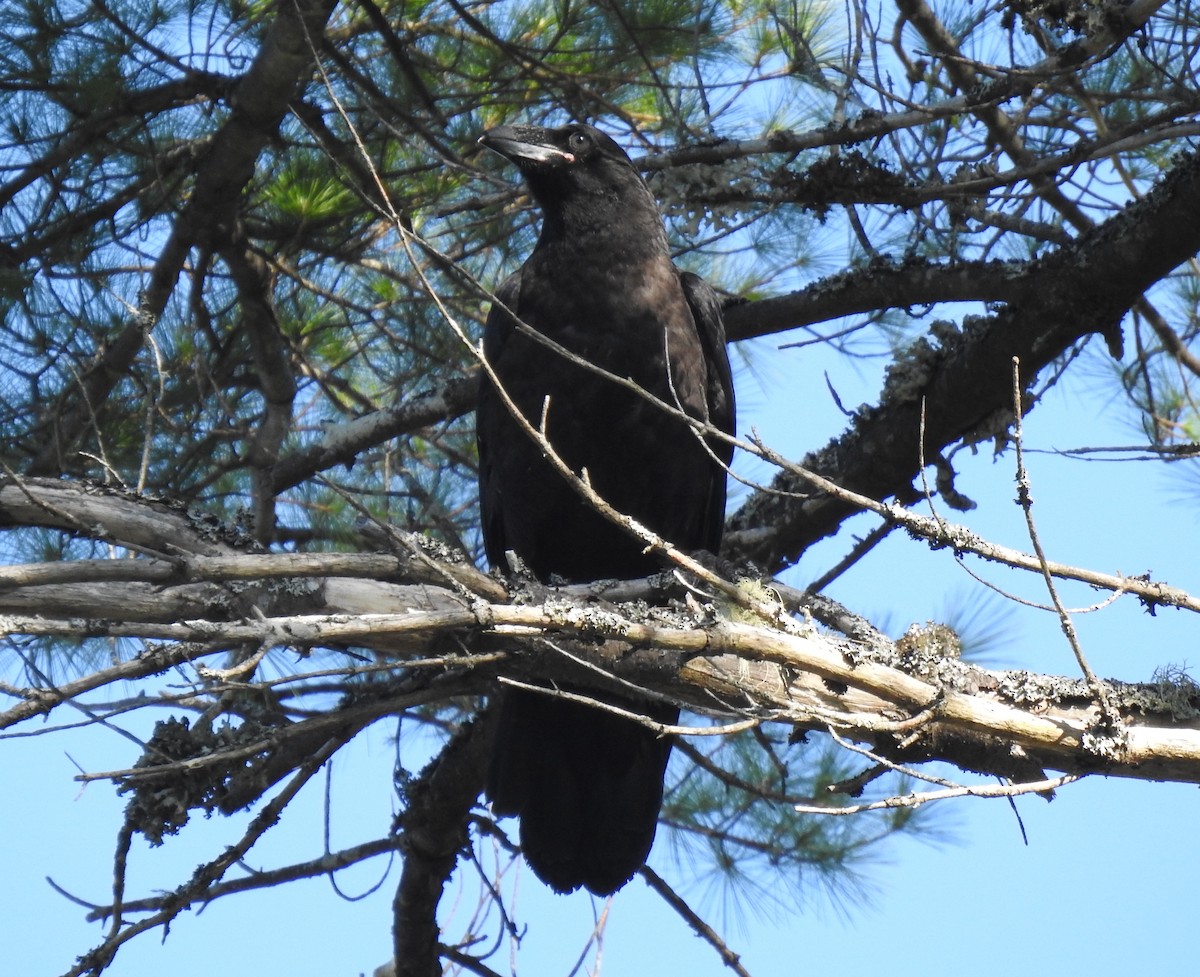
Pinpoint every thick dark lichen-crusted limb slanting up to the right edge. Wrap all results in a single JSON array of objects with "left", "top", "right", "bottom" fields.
[{"left": 726, "top": 149, "right": 1200, "bottom": 571}]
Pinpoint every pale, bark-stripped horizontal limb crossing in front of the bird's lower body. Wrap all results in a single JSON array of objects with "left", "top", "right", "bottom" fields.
[{"left": 0, "top": 573, "right": 1200, "bottom": 783}]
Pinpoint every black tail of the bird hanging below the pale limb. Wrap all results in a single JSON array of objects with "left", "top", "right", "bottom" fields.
[{"left": 487, "top": 689, "right": 679, "bottom": 895}]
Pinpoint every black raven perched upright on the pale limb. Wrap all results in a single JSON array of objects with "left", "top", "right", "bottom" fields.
[{"left": 476, "top": 125, "right": 733, "bottom": 895}]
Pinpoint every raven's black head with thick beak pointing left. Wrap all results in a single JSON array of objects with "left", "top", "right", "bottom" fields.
[{"left": 479, "top": 122, "right": 665, "bottom": 247}]
